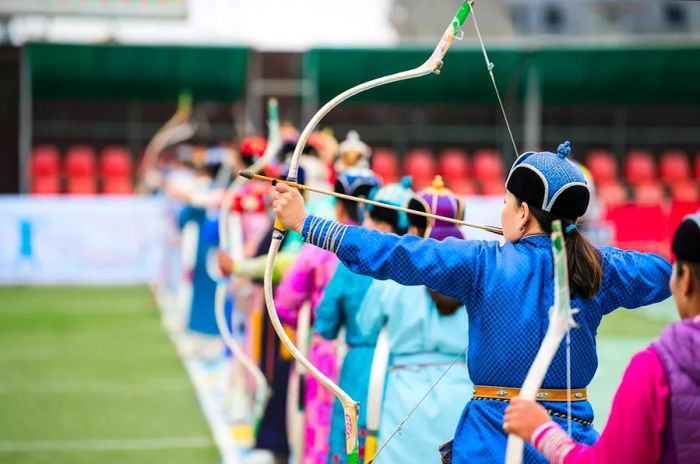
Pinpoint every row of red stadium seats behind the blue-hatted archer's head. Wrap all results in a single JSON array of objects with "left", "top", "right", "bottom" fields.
[{"left": 372, "top": 148, "right": 700, "bottom": 204}]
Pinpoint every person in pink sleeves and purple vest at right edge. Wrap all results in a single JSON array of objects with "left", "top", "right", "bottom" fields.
[{"left": 503, "top": 214, "right": 700, "bottom": 464}]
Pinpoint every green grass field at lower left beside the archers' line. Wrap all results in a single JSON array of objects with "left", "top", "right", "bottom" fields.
[{"left": 0, "top": 287, "right": 219, "bottom": 464}]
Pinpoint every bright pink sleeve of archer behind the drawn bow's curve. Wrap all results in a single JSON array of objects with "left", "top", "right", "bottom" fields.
[{"left": 275, "top": 245, "right": 313, "bottom": 327}]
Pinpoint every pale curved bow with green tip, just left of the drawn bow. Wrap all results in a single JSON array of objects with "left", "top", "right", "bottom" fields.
[{"left": 215, "top": 98, "right": 282, "bottom": 433}]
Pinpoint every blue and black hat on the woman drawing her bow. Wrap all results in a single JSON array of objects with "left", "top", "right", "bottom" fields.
[{"left": 506, "top": 141, "right": 591, "bottom": 221}]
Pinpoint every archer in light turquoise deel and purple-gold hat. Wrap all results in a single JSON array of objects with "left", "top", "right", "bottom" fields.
[{"left": 357, "top": 176, "right": 472, "bottom": 463}]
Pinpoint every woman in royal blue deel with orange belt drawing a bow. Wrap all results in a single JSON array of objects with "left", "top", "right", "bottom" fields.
[{"left": 273, "top": 142, "right": 671, "bottom": 463}]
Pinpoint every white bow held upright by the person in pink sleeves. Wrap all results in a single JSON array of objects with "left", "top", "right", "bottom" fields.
[{"left": 506, "top": 221, "right": 578, "bottom": 464}]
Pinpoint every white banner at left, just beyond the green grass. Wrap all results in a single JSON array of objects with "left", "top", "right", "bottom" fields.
[{"left": 0, "top": 196, "right": 173, "bottom": 285}]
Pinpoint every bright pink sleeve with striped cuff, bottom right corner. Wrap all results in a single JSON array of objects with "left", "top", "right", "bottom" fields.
[{"left": 533, "top": 347, "right": 669, "bottom": 464}]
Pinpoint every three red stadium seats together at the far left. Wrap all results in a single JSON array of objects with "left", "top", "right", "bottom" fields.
[{"left": 30, "top": 145, "right": 133, "bottom": 195}]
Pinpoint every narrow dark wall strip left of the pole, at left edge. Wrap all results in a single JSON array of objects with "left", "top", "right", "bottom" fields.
[{"left": 0, "top": 47, "right": 20, "bottom": 193}]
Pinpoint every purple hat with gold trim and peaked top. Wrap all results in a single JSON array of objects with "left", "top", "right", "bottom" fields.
[{"left": 416, "top": 176, "right": 464, "bottom": 240}]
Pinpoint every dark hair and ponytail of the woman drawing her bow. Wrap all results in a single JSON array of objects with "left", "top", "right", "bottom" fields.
[{"left": 528, "top": 205, "right": 603, "bottom": 298}]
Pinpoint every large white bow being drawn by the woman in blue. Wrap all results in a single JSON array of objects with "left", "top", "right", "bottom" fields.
[{"left": 264, "top": 0, "right": 474, "bottom": 464}]
